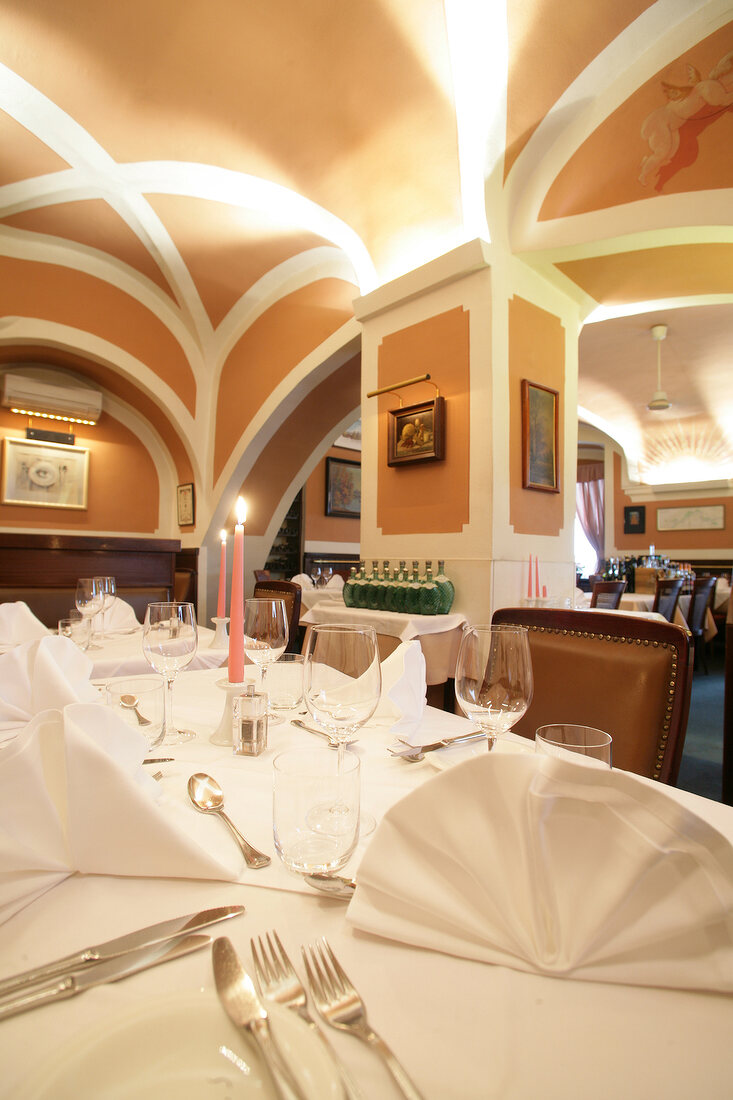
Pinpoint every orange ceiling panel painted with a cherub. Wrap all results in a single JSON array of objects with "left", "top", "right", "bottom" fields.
[{"left": 539, "top": 23, "right": 733, "bottom": 221}]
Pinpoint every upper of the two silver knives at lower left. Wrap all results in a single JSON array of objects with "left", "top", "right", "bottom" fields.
[{"left": 0, "top": 905, "right": 244, "bottom": 997}]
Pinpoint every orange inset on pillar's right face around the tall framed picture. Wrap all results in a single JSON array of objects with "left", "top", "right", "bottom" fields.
[{"left": 508, "top": 297, "right": 565, "bottom": 535}]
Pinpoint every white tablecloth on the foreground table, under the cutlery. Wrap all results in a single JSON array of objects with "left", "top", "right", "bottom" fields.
[{"left": 0, "top": 670, "right": 733, "bottom": 1100}]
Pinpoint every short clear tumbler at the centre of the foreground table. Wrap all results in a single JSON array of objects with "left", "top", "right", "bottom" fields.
[{"left": 273, "top": 749, "right": 360, "bottom": 875}]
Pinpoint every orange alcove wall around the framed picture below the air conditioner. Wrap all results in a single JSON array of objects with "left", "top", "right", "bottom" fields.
[{"left": 0, "top": 409, "right": 160, "bottom": 535}]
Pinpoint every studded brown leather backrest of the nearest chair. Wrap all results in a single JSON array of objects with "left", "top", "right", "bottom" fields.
[{"left": 493, "top": 607, "right": 692, "bottom": 784}]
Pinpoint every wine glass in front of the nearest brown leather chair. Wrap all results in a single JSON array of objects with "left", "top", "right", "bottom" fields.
[{"left": 456, "top": 624, "right": 534, "bottom": 751}]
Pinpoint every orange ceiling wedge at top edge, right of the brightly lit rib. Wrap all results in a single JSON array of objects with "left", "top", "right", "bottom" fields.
[{"left": 504, "top": 0, "right": 653, "bottom": 178}]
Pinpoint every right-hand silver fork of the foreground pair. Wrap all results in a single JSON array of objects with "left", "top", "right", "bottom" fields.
[{"left": 302, "top": 938, "right": 423, "bottom": 1100}]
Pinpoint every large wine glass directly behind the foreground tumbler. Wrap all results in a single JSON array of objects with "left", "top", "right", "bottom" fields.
[{"left": 303, "top": 624, "right": 382, "bottom": 835}]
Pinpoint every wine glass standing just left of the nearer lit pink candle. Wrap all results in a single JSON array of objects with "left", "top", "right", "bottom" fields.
[{"left": 143, "top": 603, "right": 198, "bottom": 745}]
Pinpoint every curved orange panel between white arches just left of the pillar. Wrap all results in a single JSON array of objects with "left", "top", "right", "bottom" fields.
[{"left": 214, "top": 278, "right": 357, "bottom": 482}]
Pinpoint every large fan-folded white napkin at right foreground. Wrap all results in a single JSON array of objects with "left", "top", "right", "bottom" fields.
[{"left": 348, "top": 754, "right": 733, "bottom": 992}]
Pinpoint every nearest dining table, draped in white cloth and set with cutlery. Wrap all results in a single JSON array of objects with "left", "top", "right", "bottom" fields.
[{"left": 0, "top": 669, "right": 733, "bottom": 1100}]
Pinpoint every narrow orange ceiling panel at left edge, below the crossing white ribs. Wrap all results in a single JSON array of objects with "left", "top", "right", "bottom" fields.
[{"left": 2, "top": 199, "right": 172, "bottom": 296}]
